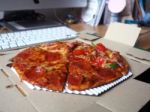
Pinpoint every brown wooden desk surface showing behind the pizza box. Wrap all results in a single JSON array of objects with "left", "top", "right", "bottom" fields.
[{"left": 70, "top": 23, "right": 150, "bottom": 51}]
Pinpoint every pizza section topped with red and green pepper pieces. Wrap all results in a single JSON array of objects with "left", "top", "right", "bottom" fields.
[{"left": 92, "top": 43, "right": 129, "bottom": 76}]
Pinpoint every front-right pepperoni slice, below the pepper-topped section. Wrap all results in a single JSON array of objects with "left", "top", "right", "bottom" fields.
[{"left": 67, "top": 59, "right": 120, "bottom": 91}]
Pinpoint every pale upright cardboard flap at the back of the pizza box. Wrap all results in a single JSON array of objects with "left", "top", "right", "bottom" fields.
[{"left": 104, "top": 23, "right": 141, "bottom": 47}]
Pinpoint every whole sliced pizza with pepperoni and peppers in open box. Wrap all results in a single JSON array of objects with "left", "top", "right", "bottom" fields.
[{"left": 12, "top": 41, "right": 129, "bottom": 91}]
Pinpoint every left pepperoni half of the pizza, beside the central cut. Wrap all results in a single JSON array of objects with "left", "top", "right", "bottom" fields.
[{"left": 12, "top": 44, "right": 67, "bottom": 91}]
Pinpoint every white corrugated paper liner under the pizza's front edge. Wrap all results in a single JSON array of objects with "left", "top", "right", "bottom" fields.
[{"left": 11, "top": 67, "right": 132, "bottom": 96}]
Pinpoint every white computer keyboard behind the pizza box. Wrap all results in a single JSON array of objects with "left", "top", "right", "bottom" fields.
[{"left": 0, "top": 26, "right": 77, "bottom": 51}]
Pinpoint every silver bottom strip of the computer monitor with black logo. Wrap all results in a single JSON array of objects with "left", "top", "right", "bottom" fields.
[{"left": 0, "top": 0, "right": 87, "bottom": 11}]
